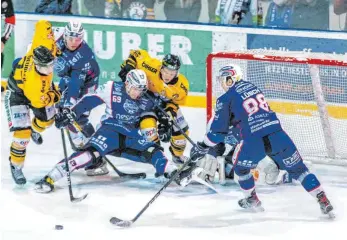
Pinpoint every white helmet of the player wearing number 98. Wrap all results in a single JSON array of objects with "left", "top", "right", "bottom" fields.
[{"left": 218, "top": 64, "right": 243, "bottom": 88}]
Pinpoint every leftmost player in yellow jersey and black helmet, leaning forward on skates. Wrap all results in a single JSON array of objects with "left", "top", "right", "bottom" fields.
[{"left": 5, "top": 45, "right": 60, "bottom": 185}]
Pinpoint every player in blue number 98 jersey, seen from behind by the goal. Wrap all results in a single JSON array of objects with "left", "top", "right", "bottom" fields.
[{"left": 191, "top": 64, "right": 333, "bottom": 217}]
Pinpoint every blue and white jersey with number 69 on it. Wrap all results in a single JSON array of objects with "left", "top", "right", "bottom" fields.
[{"left": 72, "top": 81, "right": 154, "bottom": 137}]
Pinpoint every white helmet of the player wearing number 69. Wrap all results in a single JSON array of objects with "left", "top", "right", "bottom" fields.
[{"left": 125, "top": 69, "right": 148, "bottom": 97}]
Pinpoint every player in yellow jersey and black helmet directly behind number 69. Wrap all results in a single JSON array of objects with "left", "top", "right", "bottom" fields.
[{"left": 118, "top": 50, "right": 189, "bottom": 164}]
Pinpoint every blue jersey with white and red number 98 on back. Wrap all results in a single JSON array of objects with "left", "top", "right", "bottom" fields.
[{"left": 204, "top": 80, "right": 282, "bottom": 146}]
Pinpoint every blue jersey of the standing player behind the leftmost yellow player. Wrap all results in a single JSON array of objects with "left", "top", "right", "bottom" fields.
[{"left": 54, "top": 37, "right": 100, "bottom": 105}]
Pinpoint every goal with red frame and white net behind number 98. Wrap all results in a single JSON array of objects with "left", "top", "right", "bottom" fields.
[{"left": 206, "top": 50, "right": 347, "bottom": 166}]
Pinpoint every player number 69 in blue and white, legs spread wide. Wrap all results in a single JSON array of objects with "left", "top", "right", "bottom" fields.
[{"left": 36, "top": 69, "right": 186, "bottom": 193}]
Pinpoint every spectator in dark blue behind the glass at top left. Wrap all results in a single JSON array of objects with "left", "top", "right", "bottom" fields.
[{"left": 35, "top": 0, "right": 72, "bottom": 14}]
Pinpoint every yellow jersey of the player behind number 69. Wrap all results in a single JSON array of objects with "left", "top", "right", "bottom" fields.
[{"left": 128, "top": 50, "right": 189, "bottom": 105}]
